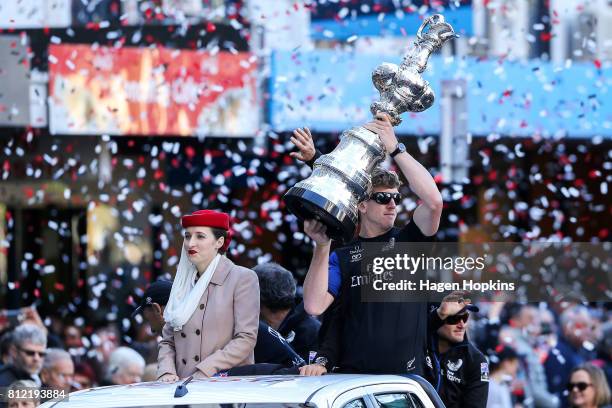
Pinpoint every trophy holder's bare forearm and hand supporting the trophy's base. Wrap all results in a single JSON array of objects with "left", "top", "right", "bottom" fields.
[{"left": 304, "top": 220, "right": 334, "bottom": 316}]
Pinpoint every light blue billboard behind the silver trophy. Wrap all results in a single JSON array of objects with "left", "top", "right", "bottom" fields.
[{"left": 269, "top": 50, "right": 612, "bottom": 138}]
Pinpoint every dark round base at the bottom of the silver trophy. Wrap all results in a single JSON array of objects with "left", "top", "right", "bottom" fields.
[{"left": 283, "top": 187, "right": 357, "bottom": 243}]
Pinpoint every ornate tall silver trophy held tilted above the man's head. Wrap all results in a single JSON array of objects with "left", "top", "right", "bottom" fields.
[{"left": 284, "top": 14, "right": 456, "bottom": 242}]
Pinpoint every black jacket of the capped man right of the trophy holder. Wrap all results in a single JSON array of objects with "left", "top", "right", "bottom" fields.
[{"left": 425, "top": 311, "right": 489, "bottom": 408}]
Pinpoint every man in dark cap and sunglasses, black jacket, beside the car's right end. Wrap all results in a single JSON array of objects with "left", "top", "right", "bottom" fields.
[{"left": 426, "top": 298, "right": 489, "bottom": 408}]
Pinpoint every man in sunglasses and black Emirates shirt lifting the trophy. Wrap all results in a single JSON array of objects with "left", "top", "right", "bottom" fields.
[{"left": 291, "top": 113, "right": 442, "bottom": 375}]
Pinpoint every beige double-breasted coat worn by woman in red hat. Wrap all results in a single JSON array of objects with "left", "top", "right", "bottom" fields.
[{"left": 157, "top": 256, "right": 259, "bottom": 378}]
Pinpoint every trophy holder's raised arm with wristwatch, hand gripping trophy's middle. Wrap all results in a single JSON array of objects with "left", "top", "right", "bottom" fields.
[{"left": 364, "top": 112, "right": 442, "bottom": 236}]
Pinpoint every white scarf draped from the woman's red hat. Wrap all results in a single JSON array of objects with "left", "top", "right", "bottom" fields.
[{"left": 164, "top": 246, "right": 221, "bottom": 331}]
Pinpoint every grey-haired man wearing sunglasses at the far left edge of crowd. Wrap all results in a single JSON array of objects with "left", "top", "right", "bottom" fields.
[{"left": 0, "top": 323, "right": 47, "bottom": 387}]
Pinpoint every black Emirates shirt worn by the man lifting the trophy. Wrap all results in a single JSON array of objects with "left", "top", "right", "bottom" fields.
[{"left": 318, "top": 222, "right": 431, "bottom": 376}]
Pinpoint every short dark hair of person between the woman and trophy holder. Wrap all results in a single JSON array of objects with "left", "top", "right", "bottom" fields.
[{"left": 253, "top": 262, "right": 296, "bottom": 311}]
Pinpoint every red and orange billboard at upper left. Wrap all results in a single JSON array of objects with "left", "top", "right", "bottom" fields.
[{"left": 49, "top": 45, "right": 259, "bottom": 136}]
